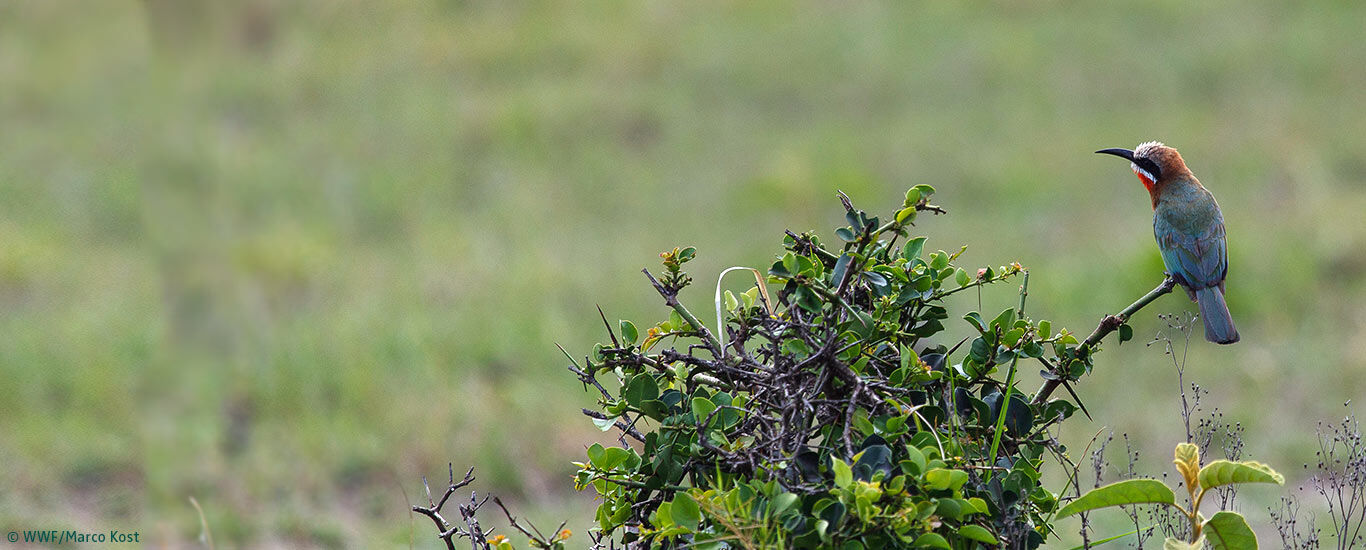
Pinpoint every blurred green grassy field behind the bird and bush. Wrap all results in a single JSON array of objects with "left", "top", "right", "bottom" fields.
[{"left": 0, "top": 0, "right": 1366, "bottom": 547}]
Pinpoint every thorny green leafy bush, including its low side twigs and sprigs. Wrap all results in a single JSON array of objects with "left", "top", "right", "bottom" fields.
[{"left": 415, "top": 186, "right": 1289, "bottom": 549}]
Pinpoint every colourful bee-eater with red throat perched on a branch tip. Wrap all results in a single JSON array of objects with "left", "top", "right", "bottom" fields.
[{"left": 1096, "top": 142, "right": 1239, "bottom": 344}]
